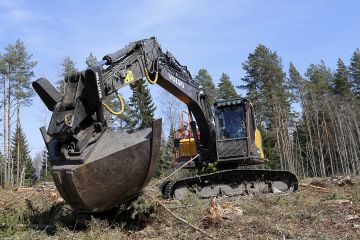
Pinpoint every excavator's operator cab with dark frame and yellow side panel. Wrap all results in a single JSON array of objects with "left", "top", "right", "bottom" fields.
[{"left": 214, "top": 99, "right": 265, "bottom": 165}]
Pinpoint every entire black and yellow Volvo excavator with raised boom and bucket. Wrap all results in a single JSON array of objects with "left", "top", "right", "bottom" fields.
[{"left": 32, "top": 37, "right": 298, "bottom": 212}]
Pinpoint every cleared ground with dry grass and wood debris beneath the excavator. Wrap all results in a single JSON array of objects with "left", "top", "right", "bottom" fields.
[{"left": 0, "top": 177, "right": 360, "bottom": 240}]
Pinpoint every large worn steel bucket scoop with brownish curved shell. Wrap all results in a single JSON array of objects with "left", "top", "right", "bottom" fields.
[{"left": 52, "top": 119, "right": 161, "bottom": 212}]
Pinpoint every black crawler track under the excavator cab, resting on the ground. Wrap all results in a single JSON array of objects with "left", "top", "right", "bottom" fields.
[{"left": 161, "top": 169, "right": 299, "bottom": 199}]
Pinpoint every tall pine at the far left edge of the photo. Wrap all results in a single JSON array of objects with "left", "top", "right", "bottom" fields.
[{"left": 0, "top": 40, "right": 37, "bottom": 186}]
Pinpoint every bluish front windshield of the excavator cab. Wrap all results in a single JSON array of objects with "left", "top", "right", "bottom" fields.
[{"left": 218, "top": 106, "right": 247, "bottom": 140}]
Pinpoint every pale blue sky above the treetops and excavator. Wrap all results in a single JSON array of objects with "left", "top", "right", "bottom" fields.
[{"left": 0, "top": 0, "right": 360, "bottom": 155}]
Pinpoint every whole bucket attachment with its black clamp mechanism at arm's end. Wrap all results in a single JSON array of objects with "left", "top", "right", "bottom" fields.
[{"left": 33, "top": 76, "right": 161, "bottom": 212}]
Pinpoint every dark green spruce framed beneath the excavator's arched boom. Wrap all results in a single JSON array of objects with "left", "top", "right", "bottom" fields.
[{"left": 129, "top": 79, "right": 156, "bottom": 131}]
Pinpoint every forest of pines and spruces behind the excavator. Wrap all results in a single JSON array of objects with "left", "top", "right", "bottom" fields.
[{"left": 0, "top": 40, "right": 360, "bottom": 186}]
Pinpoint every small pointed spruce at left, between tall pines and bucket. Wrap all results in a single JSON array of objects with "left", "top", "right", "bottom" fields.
[{"left": 11, "top": 125, "right": 37, "bottom": 185}]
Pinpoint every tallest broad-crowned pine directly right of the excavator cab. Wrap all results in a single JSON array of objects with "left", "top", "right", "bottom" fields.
[{"left": 241, "top": 44, "right": 292, "bottom": 169}]
